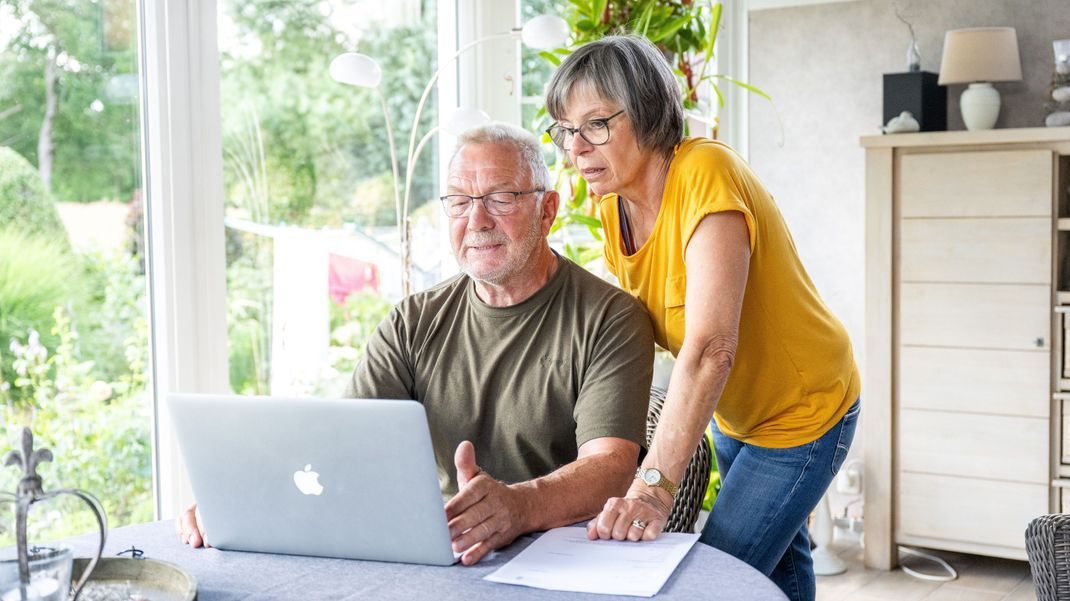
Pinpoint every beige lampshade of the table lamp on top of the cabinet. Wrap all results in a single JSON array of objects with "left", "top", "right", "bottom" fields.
[{"left": 939, "top": 27, "right": 1022, "bottom": 86}]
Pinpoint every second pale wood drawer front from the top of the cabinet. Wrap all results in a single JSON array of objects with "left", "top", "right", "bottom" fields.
[{"left": 900, "top": 217, "right": 1052, "bottom": 286}]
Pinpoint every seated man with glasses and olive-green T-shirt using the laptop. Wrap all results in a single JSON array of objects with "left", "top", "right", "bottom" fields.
[{"left": 179, "top": 124, "right": 654, "bottom": 565}]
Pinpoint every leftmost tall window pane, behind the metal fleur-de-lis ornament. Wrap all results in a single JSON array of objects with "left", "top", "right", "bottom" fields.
[{"left": 0, "top": 0, "right": 153, "bottom": 546}]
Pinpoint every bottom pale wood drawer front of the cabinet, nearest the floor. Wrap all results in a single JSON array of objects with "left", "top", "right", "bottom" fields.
[{"left": 899, "top": 474, "right": 1049, "bottom": 550}]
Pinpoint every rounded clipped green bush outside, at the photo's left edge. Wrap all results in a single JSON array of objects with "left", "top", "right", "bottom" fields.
[{"left": 0, "top": 147, "right": 68, "bottom": 240}]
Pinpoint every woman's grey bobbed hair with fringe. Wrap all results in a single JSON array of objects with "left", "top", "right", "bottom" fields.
[{"left": 546, "top": 35, "right": 684, "bottom": 156}]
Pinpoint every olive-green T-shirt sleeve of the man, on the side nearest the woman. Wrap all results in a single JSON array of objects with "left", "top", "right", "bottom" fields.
[{"left": 572, "top": 295, "right": 654, "bottom": 447}]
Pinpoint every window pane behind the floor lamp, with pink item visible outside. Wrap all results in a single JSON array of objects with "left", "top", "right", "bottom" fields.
[{"left": 219, "top": 0, "right": 442, "bottom": 396}]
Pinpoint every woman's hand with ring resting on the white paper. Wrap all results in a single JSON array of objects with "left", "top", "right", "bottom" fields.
[{"left": 587, "top": 479, "right": 672, "bottom": 541}]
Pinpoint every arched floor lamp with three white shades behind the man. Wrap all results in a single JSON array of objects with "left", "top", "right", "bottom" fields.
[{"left": 330, "top": 15, "right": 569, "bottom": 296}]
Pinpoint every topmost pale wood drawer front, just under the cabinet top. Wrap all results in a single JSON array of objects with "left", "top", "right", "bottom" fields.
[{"left": 900, "top": 150, "right": 1055, "bottom": 217}]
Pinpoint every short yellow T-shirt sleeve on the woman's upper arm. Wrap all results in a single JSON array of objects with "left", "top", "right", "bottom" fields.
[{"left": 679, "top": 147, "right": 760, "bottom": 253}]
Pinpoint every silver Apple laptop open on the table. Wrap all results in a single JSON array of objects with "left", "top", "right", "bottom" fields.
[{"left": 168, "top": 395, "right": 455, "bottom": 566}]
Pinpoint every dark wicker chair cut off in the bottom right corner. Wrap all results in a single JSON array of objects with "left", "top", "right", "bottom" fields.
[{"left": 1025, "top": 513, "right": 1070, "bottom": 601}]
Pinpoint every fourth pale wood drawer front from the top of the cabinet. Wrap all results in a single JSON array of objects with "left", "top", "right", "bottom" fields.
[{"left": 899, "top": 346, "right": 1051, "bottom": 419}]
